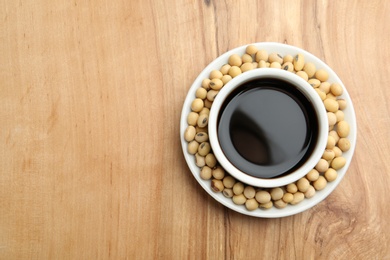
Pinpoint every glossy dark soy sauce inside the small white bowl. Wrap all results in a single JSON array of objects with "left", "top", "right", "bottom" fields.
[{"left": 217, "top": 78, "right": 318, "bottom": 178}]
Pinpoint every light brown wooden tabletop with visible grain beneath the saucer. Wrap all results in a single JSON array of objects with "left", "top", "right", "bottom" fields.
[{"left": 0, "top": 0, "right": 390, "bottom": 259}]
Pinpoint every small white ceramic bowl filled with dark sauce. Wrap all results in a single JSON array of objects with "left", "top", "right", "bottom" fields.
[{"left": 208, "top": 68, "right": 329, "bottom": 188}]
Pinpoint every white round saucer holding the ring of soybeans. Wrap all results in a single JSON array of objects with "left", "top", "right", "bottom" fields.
[{"left": 180, "top": 42, "right": 357, "bottom": 218}]
